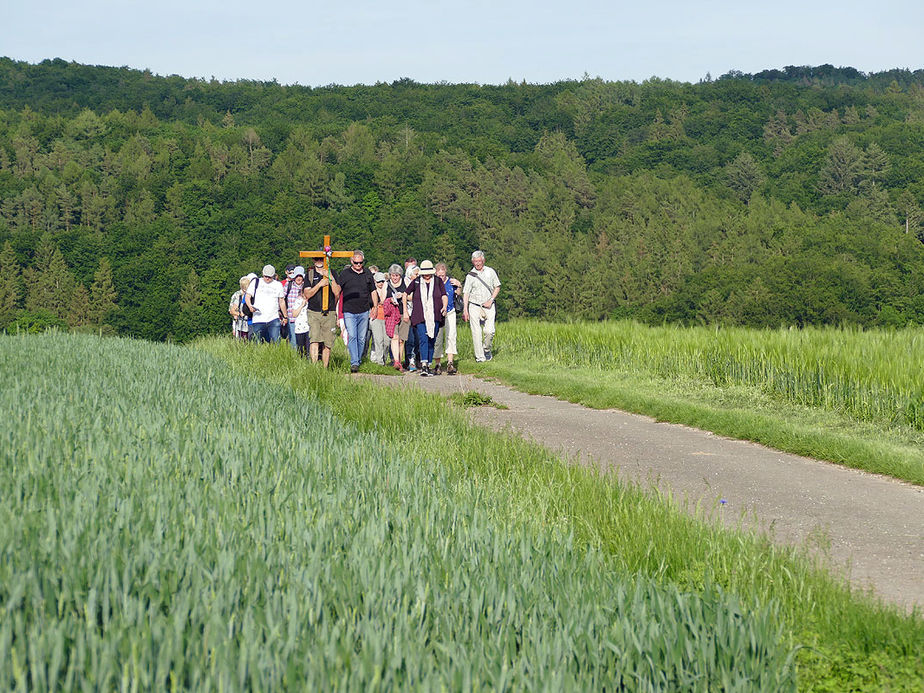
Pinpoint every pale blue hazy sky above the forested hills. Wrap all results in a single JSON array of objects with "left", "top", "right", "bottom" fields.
[{"left": 0, "top": 0, "right": 924, "bottom": 86}]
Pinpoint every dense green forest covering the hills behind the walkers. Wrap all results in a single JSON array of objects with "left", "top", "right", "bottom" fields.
[{"left": 0, "top": 58, "right": 924, "bottom": 340}]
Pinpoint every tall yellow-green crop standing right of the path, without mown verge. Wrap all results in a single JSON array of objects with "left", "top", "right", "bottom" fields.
[{"left": 500, "top": 320, "right": 924, "bottom": 430}]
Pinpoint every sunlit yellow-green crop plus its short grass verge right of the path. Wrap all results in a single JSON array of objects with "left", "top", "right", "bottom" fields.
[{"left": 472, "top": 320, "right": 924, "bottom": 484}]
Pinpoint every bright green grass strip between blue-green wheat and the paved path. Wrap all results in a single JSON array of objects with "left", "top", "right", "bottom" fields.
[{"left": 204, "top": 339, "right": 924, "bottom": 690}]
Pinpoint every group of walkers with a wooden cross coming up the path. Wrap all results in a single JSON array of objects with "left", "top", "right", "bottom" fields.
[{"left": 228, "top": 250, "right": 500, "bottom": 376}]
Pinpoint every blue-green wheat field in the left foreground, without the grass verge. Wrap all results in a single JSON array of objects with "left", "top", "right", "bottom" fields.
[{"left": 0, "top": 334, "right": 795, "bottom": 691}]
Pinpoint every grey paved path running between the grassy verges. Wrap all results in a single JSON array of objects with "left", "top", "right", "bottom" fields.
[{"left": 360, "top": 374, "right": 924, "bottom": 609}]
